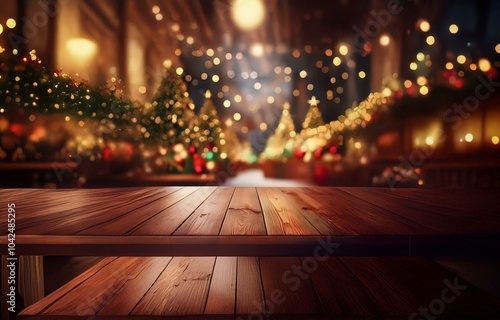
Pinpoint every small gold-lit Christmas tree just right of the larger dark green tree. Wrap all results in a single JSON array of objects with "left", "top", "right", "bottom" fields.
[{"left": 193, "top": 90, "right": 226, "bottom": 153}]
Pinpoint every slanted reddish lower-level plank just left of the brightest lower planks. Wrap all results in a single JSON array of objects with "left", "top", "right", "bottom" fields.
[{"left": 98, "top": 257, "right": 172, "bottom": 316}]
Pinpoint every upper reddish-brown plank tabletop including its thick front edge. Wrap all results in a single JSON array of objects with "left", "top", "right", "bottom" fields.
[{"left": 0, "top": 187, "right": 500, "bottom": 256}]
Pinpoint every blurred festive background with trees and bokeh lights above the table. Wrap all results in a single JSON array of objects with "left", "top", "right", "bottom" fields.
[{"left": 0, "top": 0, "right": 500, "bottom": 188}]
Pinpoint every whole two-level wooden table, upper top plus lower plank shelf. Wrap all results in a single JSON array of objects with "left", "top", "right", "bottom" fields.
[{"left": 0, "top": 187, "right": 500, "bottom": 319}]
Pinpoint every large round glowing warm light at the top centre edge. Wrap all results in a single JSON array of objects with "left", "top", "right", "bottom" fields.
[{"left": 231, "top": 0, "right": 265, "bottom": 30}]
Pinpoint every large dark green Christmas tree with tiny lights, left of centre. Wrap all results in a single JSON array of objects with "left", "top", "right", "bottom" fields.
[{"left": 141, "top": 66, "right": 192, "bottom": 147}]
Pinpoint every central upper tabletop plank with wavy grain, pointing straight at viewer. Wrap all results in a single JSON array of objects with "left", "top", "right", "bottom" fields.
[{"left": 220, "top": 188, "right": 266, "bottom": 235}]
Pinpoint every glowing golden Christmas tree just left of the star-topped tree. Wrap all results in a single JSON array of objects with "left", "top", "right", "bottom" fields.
[{"left": 261, "top": 103, "right": 296, "bottom": 159}]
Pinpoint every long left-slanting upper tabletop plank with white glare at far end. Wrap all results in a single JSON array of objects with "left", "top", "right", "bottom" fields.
[{"left": 78, "top": 187, "right": 199, "bottom": 235}]
